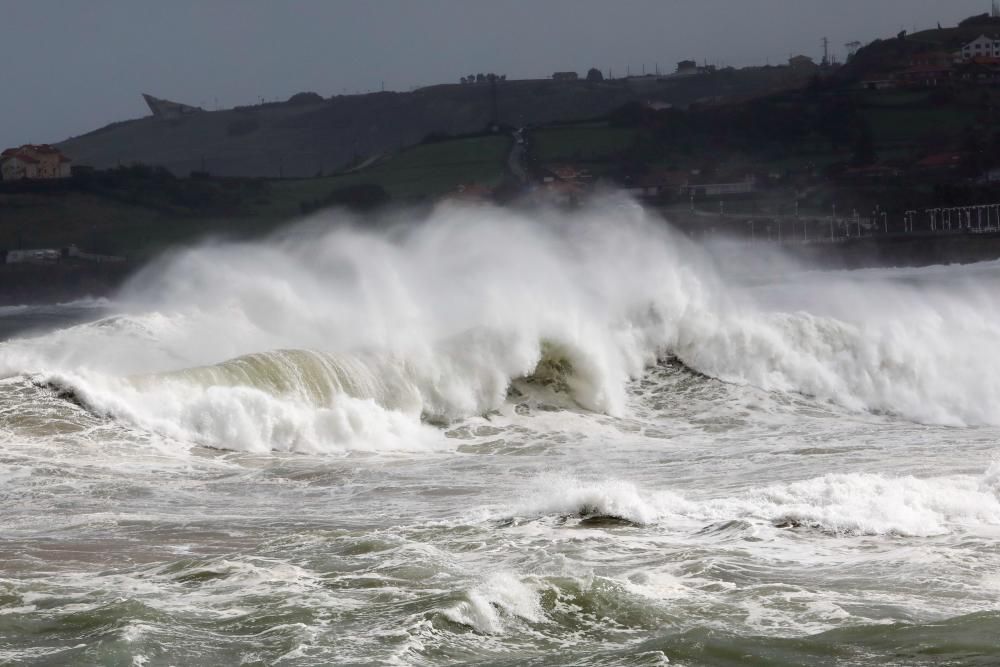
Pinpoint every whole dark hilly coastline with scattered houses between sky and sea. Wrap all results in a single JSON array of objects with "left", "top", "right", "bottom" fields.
[{"left": 9, "top": 6, "right": 1000, "bottom": 272}]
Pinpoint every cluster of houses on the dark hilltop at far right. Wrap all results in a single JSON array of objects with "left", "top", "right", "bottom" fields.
[{"left": 862, "top": 35, "right": 1000, "bottom": 90}]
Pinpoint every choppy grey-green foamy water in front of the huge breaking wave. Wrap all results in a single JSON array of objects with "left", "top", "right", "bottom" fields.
[{"left": 0, "top": 354, "right": 1000, "bottom": 665}]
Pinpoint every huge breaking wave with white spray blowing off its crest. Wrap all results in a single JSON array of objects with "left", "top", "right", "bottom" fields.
[{"left": 0, "top": 199, "right": 1000, "bottom": 451}]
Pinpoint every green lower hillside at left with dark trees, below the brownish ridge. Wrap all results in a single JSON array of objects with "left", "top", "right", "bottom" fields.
[{"left": 0, "top": 135, "right": 511, "bottom": 261}]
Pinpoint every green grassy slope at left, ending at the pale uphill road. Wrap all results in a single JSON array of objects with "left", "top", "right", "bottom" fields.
[{"left": 0, "top": 136, "right": 510, "bottom": 261}]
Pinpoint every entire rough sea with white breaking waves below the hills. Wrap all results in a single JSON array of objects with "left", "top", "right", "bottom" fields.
[{"left": 0, "top": 199, "right": 1000, "bottom": 666}]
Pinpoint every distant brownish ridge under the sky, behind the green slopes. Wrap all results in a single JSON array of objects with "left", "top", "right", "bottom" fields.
[{"left": 59, "top": 67, "right": 807, "bottom": 178}]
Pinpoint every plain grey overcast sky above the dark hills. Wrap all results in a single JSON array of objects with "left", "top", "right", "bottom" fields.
[{"left": 0, "top": 0, "right": 990, "bottom": 146}]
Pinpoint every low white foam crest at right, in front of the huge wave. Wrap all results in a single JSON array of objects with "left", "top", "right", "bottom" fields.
[{"left": 506, "top": 464, "right": 1000, "bottom": 536}]
